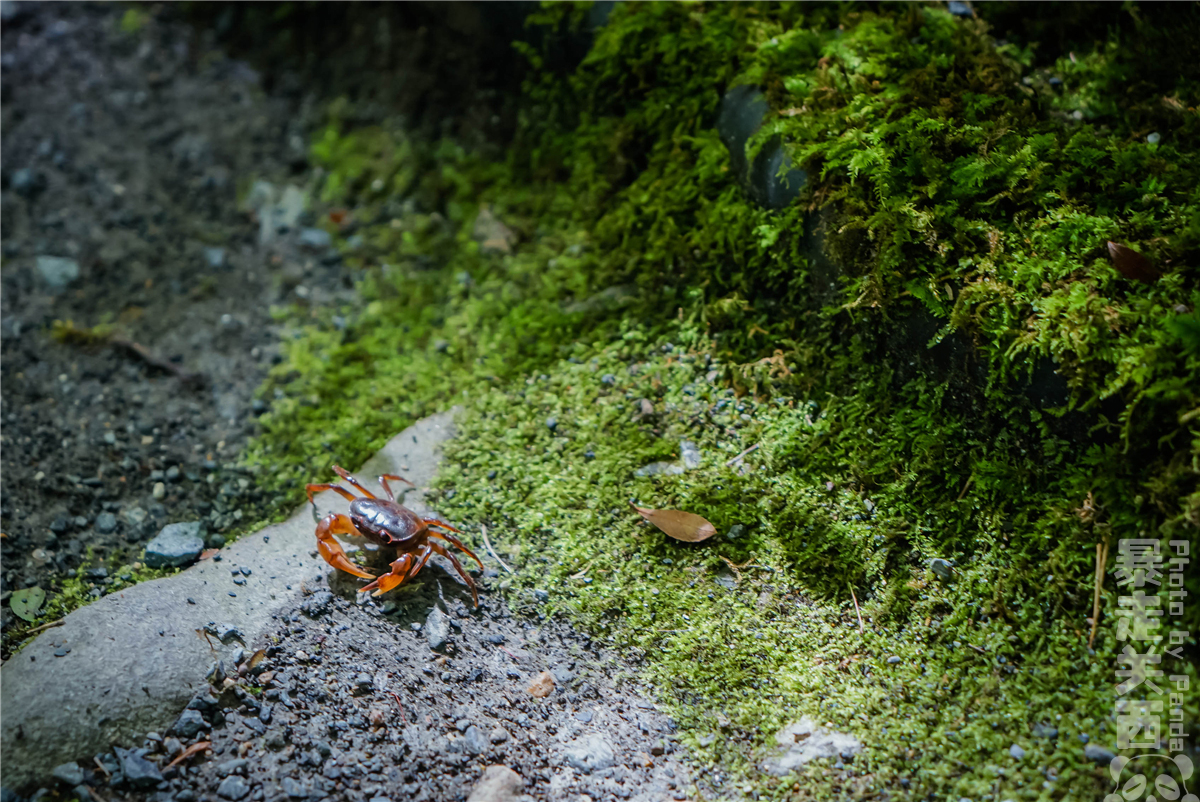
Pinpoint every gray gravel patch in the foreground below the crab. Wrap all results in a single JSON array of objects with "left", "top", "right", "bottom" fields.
[{"left": 55, "top": 583, "right": 691, "bottom": 802}]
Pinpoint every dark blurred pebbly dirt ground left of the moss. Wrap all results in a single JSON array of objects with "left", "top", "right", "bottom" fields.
[{"left": 0, "top": 4, "right": 350, "bottom": 627}]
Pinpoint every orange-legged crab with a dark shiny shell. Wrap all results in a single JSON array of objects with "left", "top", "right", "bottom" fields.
[{"left": 305, "top": 465, "right": 484, "bottom": 608}]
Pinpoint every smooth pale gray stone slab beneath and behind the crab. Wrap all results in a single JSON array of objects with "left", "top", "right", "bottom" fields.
[{"left": 0, "top": 408, "right": 457, "bottom": 788}]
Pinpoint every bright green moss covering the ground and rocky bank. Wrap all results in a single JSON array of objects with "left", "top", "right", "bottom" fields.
[{"left": 28, "top": 4, "right": 1200, "bottom": 800}]
